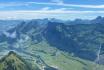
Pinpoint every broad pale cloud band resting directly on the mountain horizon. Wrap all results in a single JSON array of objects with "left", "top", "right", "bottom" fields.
[{"left": 0, "top": 9, "right": 104, "bottom": 19}]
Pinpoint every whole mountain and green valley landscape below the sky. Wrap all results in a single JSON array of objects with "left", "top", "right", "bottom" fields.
[{"left": 0, "top": 16, "right": 104, "bottom": 70}]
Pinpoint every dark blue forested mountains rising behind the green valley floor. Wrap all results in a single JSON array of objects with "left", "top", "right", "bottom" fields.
[{"left": 0, "top": 17, "right": 104, "bottom": 60}]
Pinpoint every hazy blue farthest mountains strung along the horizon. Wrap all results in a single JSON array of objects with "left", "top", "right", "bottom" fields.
[{"left": 0, "top": 16, "right": 104, "bottom": 31}]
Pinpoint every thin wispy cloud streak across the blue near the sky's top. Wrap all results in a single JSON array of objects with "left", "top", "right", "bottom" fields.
[{"left": 0, "top": 0, "right": 104, "bottom": 9}]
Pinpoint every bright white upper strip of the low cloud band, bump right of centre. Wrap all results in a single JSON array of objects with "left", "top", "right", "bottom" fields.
[{"left": 0, "top": 8, "right": 104, "bottom": 15}]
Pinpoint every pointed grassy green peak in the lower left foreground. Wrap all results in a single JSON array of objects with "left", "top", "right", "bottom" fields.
[{"left": 0, "top": 51, "right": 31, "bottom": 70}]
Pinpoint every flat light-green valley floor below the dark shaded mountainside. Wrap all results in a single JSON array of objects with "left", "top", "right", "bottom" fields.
[{"left": 25, "top": 42, "right": 104, "bottom": 70}]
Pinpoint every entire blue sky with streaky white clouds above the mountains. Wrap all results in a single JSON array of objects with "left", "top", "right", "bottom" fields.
[{"left": 0, "top": 0, "right": 104, "bottom": 20}]
